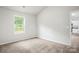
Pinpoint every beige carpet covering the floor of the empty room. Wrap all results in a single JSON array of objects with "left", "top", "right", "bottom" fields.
[{"left": 0, "top": 38, "right": 79, "bottom": 53}]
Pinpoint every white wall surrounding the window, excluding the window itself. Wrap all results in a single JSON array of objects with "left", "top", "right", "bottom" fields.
[{"left": 0, "top": 8, "right": 37, "bottom": 45}]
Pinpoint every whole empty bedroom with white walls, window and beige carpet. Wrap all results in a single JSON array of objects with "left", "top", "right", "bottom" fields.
[{"left": 0, "top": 6, "right": 79, "bottom": 53}]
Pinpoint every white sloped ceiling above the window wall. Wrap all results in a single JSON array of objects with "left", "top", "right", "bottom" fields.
[{"left": 3, "top": 6, "right": 45, "bottom": 15}]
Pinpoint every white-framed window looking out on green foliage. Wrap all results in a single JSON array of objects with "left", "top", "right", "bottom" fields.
[{"left": 14, "top": 16, "right": 25, "bottom": 33}]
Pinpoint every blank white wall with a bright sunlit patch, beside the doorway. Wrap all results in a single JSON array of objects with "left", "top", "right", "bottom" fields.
[{"left": 37, "top": 6, "right": 77, "bottom": 45}]
